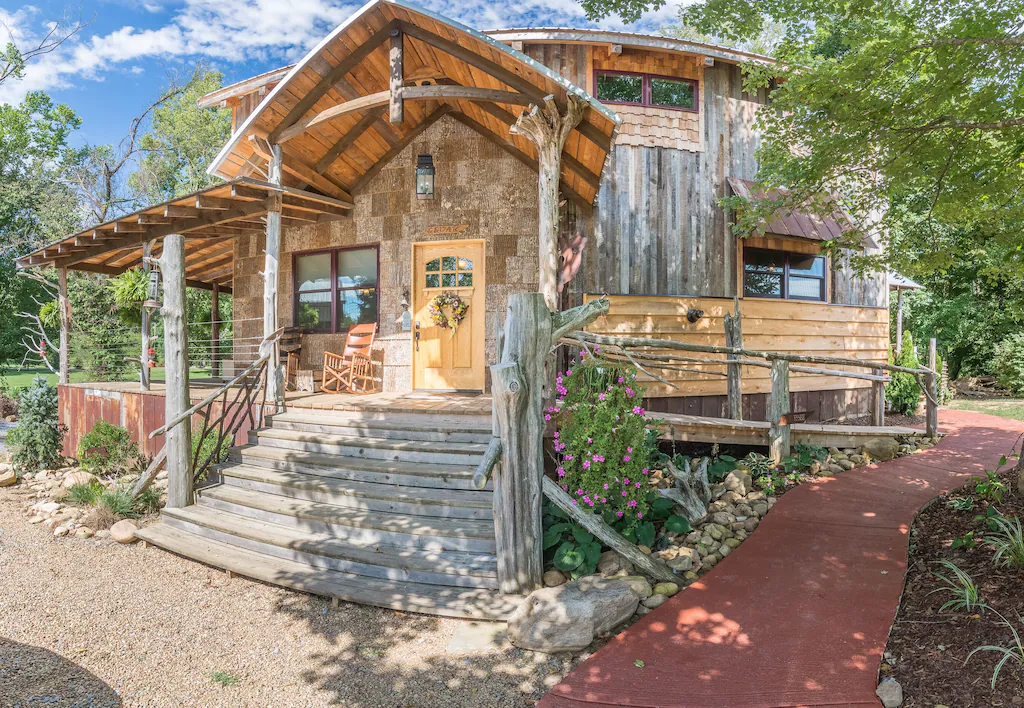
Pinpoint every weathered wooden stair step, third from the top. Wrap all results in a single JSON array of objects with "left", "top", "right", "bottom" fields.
[{"left": 228, "top": 445, "right": 483, "bottom": 490}]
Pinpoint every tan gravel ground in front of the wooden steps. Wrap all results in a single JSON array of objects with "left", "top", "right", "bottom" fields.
[{"left": 0, "top": 487, "right": 569, "bottom": 708}]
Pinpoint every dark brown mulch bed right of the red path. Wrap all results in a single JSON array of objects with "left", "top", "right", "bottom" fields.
[{"left": 882, "top": 471, "right": 1024, "bottom": 708}]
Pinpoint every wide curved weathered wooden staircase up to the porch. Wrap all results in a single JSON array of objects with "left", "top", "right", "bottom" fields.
[{"left": 138, "top": 410, "right": 519, "bottom": 620}]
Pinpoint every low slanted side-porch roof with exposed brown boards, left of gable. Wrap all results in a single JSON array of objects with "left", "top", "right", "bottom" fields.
[{"left": 16, "top": 178, "right": 352, "bottom": 292}]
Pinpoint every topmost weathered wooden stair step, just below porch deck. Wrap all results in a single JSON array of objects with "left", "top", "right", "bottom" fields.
[{"left": 269, "top": 410, "right": 492, "bottom": 445}]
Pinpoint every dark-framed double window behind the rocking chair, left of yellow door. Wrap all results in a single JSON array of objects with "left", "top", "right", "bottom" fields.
[{"left": 293, "top": 247, "right": 378, "bottom": 333}]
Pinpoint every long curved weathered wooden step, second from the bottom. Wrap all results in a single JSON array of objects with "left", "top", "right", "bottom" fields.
[{"left": 162, "top": 505, "right": 498, "bottom": 589}]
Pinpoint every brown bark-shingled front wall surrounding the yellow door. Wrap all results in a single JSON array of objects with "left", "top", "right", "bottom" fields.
[{"left": 233, "top": 117, "right": 539, "bottom": 391}]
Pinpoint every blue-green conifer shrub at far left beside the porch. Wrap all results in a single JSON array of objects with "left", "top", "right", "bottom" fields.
[{"left": 7, "top": 376, "right": 68, "bottom": 474}]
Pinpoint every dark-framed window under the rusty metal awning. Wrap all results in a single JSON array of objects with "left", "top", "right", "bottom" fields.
[{"left": 743, "top": 248, "right": 825, "bottom": 302}]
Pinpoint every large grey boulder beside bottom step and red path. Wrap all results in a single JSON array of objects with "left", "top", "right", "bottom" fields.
[{"left": 508, "top": 576, "right": 640, "bottom": 654}]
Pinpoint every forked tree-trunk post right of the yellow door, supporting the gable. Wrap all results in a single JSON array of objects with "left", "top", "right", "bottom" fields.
[{"left": 509, "top": 93, "right": 585, "bottom": 311}]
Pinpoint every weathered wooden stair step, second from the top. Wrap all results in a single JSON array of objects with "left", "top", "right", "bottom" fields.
[{"left": 250, "top": 428, "right": 487, "bottom": 465}]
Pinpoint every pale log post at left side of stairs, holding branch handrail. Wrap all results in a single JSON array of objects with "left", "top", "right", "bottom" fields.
[{"left": 160, "top": 234, "right": 193, "bottom": 509}]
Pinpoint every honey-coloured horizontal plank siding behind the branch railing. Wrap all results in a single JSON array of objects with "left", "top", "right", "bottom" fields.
[{"left": 585, "top": 294, "right": 889, "bottom": 398}]
